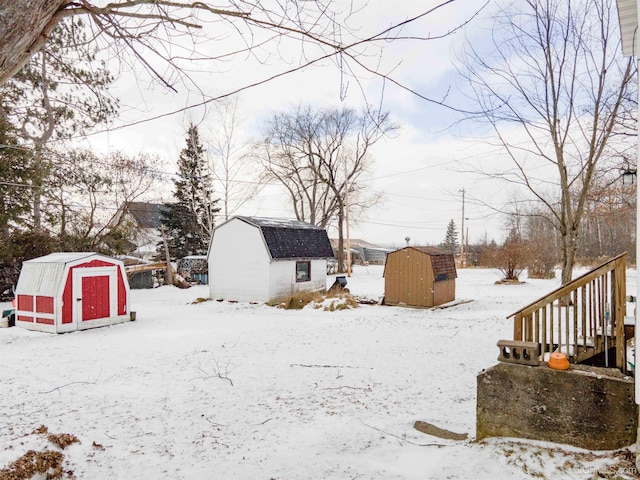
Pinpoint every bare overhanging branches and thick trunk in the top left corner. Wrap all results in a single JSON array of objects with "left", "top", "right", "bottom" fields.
[{"left": 0, "top": 0, "right": 482, "bottom": 115}]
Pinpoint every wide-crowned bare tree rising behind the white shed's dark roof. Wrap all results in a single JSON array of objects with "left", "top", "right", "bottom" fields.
[{"left": 257, "top": 106, "right": 397, "bottom": 268}]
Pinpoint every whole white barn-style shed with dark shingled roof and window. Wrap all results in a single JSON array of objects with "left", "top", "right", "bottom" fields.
[{"left": 207, "top": 216, "right": 333, "bottom": 302}]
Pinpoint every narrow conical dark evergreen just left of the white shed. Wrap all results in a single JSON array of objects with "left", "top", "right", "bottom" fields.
[{"left": 159, "top": 124, "right": 220, "bottom": 259}]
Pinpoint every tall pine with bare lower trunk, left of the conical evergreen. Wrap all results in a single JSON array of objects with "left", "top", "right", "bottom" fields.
[{"left": 0, "top": 18, "right": 118, "bottom": 230}]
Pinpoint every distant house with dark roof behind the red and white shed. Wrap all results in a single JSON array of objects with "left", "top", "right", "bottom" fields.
[{"left": 117, "top": 202, "right": 165, "bottom": 261}]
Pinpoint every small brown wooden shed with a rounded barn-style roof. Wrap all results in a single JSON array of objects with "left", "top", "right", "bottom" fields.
[{"left": 383, "top": 247, "right": 458, "bottom": 307}]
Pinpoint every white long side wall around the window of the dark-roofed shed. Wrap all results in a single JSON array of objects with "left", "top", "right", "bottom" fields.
[{"left": 269, "top": 259, "right": 327, "bottom": 300}]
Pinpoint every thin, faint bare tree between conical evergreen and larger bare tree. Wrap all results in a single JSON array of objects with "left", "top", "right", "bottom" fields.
[{"left": 207, "top": 98, "right": 262, "bottom": 220}]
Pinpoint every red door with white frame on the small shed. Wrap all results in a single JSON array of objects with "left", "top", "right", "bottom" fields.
[{"left": 73, "top": 267, "right": 118, "bottom": 328}]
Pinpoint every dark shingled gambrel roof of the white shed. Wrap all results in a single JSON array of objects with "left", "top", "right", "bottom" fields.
[{"left": 236, "top": 216, "right": 333, "bottom": 259}]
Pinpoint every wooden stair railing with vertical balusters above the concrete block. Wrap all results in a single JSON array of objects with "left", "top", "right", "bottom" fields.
[{"left": 507, "top": 252, "right": 627, "bottom": 372}]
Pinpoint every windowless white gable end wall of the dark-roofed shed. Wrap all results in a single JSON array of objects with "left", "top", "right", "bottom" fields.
[{"left": 209, "top": 219, "right": 269, "bottom": 302}]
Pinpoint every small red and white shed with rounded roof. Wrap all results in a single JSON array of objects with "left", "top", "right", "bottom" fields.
[{"left": 15, "top": 252, "right": 130, "bottom": 333}]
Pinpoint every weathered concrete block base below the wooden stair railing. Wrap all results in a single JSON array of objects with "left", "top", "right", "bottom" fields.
[{"left": 476, "top": 363, "right": 638, "bottom": 450}]
